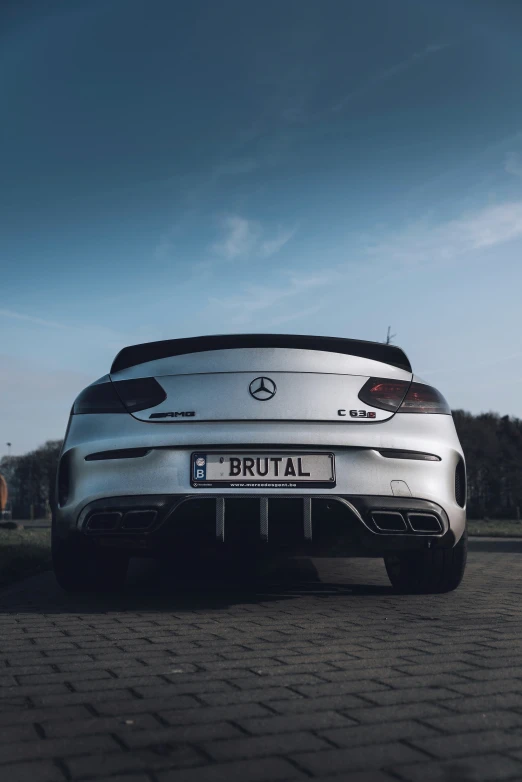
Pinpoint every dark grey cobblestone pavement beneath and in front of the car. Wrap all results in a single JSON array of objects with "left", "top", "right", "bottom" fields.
[{"left": 0, "top": 551, "right": 522, "bottom": 782}]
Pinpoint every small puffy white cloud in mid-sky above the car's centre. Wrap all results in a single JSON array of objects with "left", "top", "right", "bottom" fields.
[{"left": 211, "top": 215, "right": 297, "bottom": 261}]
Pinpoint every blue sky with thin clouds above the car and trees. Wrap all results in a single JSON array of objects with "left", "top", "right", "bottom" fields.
[{"left": 0, "top": 0, "right": 522, "bottom": 454}]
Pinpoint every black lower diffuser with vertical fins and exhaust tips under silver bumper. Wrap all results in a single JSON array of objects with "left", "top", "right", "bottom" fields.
[{"left": 55, "top": 494, "right": 465, "bottom": 556}]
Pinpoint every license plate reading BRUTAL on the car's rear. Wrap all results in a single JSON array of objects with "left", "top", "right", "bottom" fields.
[{"left": 191, "top": 452, "right": 335, "bottom": 489}]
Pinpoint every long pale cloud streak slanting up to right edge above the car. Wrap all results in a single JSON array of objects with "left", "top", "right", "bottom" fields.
[{"left": 205, "top": 201, "right": 522, "bottom": 325}]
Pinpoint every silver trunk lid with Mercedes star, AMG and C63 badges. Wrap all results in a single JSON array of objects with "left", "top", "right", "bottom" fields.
[{"left": 111, "top": 343, "right": 412, "bottom": 423}]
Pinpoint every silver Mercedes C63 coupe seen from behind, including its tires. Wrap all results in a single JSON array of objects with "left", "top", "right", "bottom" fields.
[{"left": 52, "top": 334, "right": 466, "bottom": 592}]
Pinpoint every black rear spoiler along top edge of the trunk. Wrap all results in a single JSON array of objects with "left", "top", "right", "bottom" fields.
[{"left": 111, "top": 334, "right": 412, "bottom": 372}]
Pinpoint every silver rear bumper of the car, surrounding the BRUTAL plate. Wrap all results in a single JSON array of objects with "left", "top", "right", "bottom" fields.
[{"left": 55, "top": 415, "right": 466, "bottom": 551}]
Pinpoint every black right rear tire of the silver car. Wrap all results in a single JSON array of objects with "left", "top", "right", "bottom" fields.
[{"left": 384, "top": 532, "right": 468, "bottom": 595}]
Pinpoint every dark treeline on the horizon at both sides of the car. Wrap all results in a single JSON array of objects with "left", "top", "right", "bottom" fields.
[{"left": 0, "top": 410, "right": 522, "bottom": 519}]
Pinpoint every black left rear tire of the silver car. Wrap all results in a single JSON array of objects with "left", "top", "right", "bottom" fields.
[{"left": 52, "top": 535, "right": 129, "bottom": 592}]
